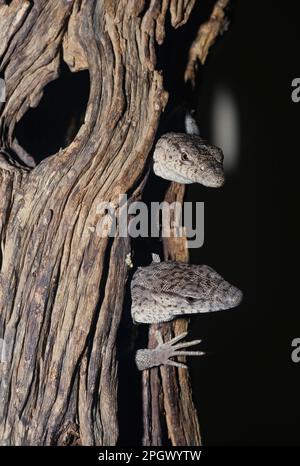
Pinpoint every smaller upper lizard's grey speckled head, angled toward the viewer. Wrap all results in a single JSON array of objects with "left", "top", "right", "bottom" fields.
[{"left": 153, "top": 133, "right": 225, "bottom": 188}]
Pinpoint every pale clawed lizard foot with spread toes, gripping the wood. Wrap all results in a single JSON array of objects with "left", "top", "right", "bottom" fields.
[{"left": 135, "top": 331, "right": 205, "bottom": 371}]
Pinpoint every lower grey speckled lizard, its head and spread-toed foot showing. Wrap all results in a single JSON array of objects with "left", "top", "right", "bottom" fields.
[{"left": 131, "top": 261, "right": 243, "bottom": 370}]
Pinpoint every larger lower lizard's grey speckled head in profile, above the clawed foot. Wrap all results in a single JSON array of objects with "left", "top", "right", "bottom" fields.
[{"left": 131, "top": 261, "right": 243, "bottom": 323}]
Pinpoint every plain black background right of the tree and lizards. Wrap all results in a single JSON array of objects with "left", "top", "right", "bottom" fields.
[{"left": 188, "top": 0, "right": 300, "bottom": 445}]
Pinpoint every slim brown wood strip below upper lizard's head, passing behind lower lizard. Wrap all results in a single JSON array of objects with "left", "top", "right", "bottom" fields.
[{"left": 143, "top": 183, "right": 201, "bottom": 446}]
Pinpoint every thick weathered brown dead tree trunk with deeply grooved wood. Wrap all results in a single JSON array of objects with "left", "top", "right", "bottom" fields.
[{"left": 0, "top": 0, "right": 229, "bottom": 445}]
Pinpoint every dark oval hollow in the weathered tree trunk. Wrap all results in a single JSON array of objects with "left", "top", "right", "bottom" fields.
[{"left": 14, "top": 63, "right": 90, "bottom": 164}]
